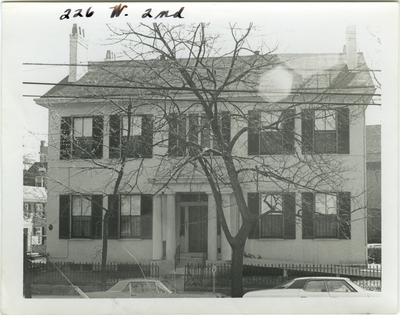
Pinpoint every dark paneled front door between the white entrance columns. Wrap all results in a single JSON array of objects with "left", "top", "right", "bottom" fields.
[{"left": 188, "top": 206, "right": 208, "bottom": 252}]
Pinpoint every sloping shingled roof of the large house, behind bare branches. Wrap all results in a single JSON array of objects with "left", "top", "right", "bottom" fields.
[{"left": 36, "top": 53, "right": 375, "bottom": 104}]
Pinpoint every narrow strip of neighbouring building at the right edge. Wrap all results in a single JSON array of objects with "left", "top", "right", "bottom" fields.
[{"left": 366, "top": 125, "right": 382, "bottom": 244}]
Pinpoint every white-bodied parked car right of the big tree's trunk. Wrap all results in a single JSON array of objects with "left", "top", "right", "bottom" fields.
[{"left": 243, "top": 277, "right": 380, "bottom": 298}]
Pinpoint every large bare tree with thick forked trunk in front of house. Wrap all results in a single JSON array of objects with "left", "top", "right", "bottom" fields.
[{"left": 97, "top": 24, "right": 373, "bottom": 297}]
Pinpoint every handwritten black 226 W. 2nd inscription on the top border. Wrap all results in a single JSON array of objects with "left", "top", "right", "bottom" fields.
[{"left": 60, "top": 4, "right": 185, "bottom": 20}]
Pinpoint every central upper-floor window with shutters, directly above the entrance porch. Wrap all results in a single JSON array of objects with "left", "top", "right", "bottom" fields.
[{"left": 168, "top": 111, "right": 231, "bottom": 157}]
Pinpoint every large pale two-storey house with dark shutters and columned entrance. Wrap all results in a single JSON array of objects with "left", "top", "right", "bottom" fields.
[{"left": 36, "top": 25, "right": 375, "bottom": 264}]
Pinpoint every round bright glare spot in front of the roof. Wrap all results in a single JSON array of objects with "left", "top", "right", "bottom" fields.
[{"left": 258, "top": 66, "right": 293, "bottom": 102}]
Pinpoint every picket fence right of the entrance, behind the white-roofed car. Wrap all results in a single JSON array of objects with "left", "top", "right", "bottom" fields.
[{"left": 185, "top": 264, "right": 381, "bottom": 295}]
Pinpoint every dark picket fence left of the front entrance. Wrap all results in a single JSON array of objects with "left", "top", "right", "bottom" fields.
[{"left": 30, "top": 262, "right": 159, "bottom": 286}]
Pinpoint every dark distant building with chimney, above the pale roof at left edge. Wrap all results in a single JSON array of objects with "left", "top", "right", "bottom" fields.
[{"left": 24, "top": 140, "right": 48, "bottom": 187}]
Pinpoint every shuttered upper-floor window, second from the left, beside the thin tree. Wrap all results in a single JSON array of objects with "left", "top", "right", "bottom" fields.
[{"left": 110, "top": 115, "right": 153, "bottom": 158}]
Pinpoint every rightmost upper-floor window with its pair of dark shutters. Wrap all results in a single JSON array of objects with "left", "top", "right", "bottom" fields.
[{"left": 302, "top": 108, "right": 350, "bottom": 154}]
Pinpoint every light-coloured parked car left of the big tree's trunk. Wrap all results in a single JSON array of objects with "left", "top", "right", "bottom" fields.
[{"left": 86, "top": 279, "right": 225, "bottom": 298}]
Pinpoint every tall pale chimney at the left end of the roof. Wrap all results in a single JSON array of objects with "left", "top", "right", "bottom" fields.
[{"left": 68, "top": 24, "right": 88, "bottom": 82}]
